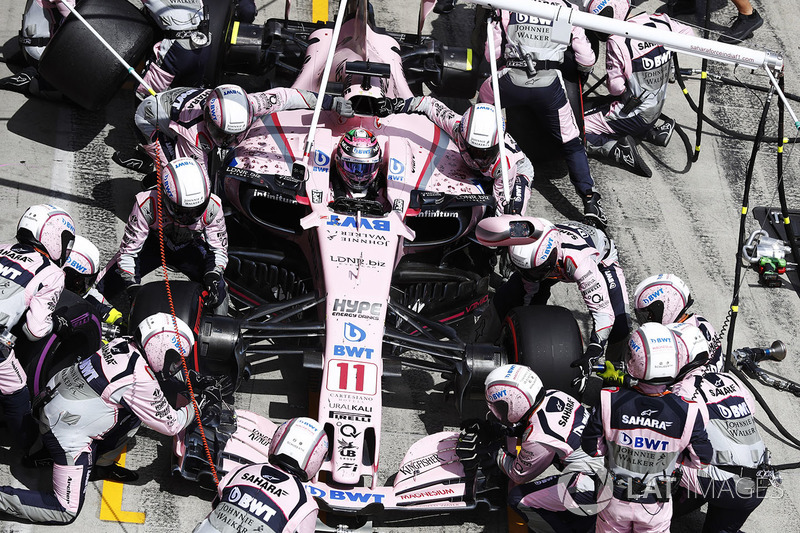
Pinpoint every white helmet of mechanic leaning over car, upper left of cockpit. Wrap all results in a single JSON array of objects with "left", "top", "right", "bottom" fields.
[{"left": 203, "top": 84, "right": 253, "bottom": 148}]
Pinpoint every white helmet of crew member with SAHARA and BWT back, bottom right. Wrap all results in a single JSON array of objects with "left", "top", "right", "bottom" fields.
[{"left": 626, "top": 322, "right": 680, "bottom": 385}]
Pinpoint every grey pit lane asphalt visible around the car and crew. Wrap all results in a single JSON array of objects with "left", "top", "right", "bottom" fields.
[{"left": 0, "top": 0, "right": 800, "bottom": 533}]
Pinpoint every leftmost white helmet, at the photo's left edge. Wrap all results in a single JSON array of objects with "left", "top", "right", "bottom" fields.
[{"left": 17, "top": 204, "right": 75, "bottom": 267}]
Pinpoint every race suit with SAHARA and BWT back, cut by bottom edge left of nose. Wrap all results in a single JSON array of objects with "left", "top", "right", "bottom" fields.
[{"left": 194, "top": 463, "right": 318, "bottom": 533}]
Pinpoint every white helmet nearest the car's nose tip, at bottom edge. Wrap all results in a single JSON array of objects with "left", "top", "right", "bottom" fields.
[{"left": 269, "top": 417, "right": 328, "bottom": 482}]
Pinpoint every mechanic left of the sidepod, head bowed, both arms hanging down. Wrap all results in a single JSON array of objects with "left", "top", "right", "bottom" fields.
[{"left": 100, "top": 157, "right": 228, "bottom": 313}]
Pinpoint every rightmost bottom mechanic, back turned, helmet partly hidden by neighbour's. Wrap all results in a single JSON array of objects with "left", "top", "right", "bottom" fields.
[{"left": 669, "top": 323, "right": 774, "bottom": 533}]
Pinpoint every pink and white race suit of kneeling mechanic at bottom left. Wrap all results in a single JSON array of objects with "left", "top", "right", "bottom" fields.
[{"left": 0, "top": 338, "right": 193, "bottom": 524}]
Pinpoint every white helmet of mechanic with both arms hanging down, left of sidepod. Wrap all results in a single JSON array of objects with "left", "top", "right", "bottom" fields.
[{"left": 161, "top": 157, "right": 211, "bottom": 226}]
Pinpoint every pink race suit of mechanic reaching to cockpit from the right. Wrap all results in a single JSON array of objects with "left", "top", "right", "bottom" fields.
[{"left": 403, "top": 96, "right": 533, "bottom": 215}]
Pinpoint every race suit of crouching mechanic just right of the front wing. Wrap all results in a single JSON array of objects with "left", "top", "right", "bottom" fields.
[{"left": 498, "top": 390, "right": 604, "bottom": 531}]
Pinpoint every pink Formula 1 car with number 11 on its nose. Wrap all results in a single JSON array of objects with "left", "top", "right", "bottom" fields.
[{"left": 158, "top": 1, "right": 582, "bottom": 515}]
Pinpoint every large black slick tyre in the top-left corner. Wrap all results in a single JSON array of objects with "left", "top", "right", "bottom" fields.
[{"left": 39, "top": 0, "right": 154, "bottom": 110}]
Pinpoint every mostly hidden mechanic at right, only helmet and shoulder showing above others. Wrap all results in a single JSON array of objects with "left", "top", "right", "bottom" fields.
[{"left": 633, "top": 274, "right": 725, "bottom": 372}]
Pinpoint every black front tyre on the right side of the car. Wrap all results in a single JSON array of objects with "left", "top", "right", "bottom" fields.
[{"left": 500, "top": 305, "right": 583, "bottom": 395}]
